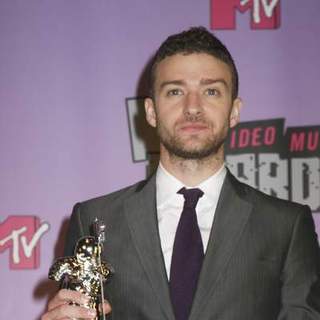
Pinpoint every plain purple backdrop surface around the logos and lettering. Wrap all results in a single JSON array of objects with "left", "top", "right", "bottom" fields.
[{"left": 0, "top": 0, "right": 320, "bottom": 319}]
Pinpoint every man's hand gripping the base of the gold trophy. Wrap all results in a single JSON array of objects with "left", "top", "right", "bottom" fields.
[{"left": 41, "top": 289, "right": 111, "bottom": 320}]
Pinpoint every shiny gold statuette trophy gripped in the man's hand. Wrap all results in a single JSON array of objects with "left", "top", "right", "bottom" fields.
[{"left": 48, "top": 218, "right": 113, "bottom": 320}]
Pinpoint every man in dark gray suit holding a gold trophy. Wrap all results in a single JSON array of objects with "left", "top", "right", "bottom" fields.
[{"left": 42, "top": 28, "right": 320, "bottom": 320}]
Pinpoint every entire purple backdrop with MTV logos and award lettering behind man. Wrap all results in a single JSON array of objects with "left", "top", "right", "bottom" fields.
[{"left": 0, "top": 0, "right": 320, "bottom": 319}]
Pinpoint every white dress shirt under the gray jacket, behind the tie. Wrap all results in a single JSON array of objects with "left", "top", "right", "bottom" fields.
[{"left": 156, "top": 163, "right": 227, "bottom": 279}]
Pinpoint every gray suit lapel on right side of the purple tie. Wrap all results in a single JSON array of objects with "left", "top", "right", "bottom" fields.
[{"left": 190, "top": 172, "right": 252, "bottom": 320}]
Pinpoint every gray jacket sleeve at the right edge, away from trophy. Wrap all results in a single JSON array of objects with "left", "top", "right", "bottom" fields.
[{"left": 278, "top": 206, "right": 320, "bottom": 320}]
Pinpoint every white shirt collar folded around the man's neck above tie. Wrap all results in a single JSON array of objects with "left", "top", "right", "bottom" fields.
[{"left": 156, "top": 162, "right": 227, "bottom": 206}]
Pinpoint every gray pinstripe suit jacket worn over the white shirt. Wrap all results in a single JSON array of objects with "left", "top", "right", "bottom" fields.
[{"left": 65, "top": 173, "right": 320, "bottom": 320}]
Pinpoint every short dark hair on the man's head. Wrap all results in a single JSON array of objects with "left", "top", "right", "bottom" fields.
[{"left": 150, "top": 27, "right": 239, "bottom": 99}]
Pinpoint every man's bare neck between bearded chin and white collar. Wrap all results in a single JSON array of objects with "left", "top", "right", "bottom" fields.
[{"left": 160, "top": 148, "right": 224, "bottom": 187}]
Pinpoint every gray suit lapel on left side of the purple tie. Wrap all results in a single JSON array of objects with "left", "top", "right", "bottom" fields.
[{"left": 124, "top": 175, "right": 174, "bottom": 320}]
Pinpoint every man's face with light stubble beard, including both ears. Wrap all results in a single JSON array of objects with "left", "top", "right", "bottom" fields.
[{"left": 145, "top": 53, "right": 241, "bottom": 159}]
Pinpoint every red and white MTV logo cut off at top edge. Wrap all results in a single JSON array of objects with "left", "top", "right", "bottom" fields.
[{"left": 211, "top": 0, "right": 280, "bottom": 30}]
